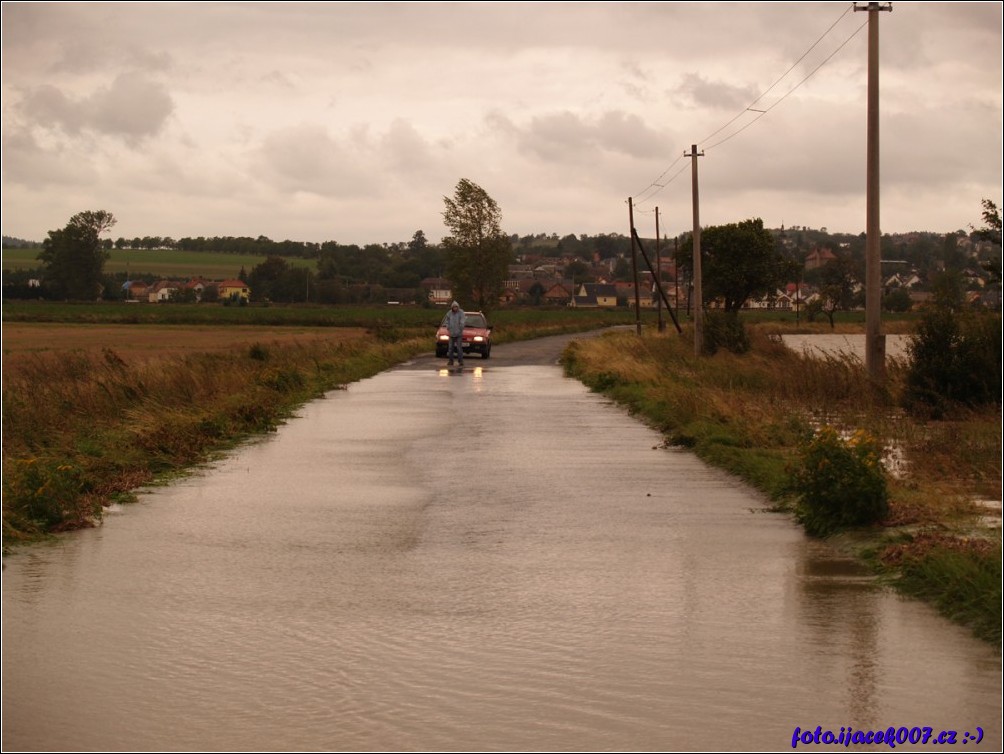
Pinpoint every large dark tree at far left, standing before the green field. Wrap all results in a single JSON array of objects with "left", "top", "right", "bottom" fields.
[{"left": 38, "top": 210, "right": 115, "bottom": 300}]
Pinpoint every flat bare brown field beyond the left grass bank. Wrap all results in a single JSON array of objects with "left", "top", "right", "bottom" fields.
[{"left": 3, "top": 322, "right": 366, "bottom": 371}]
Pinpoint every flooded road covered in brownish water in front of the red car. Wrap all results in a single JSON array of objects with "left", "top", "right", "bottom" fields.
[{"left": 3, "top": 337, "right": 1001, "bottom": 751}]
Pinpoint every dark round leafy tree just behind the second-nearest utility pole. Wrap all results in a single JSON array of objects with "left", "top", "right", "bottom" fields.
[{"left": 677, "top": 218, "right": 795, "bottom": 312}]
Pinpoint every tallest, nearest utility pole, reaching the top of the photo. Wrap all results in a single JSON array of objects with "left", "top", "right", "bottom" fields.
[{"left": 854, "top": 2, "right": 893, "bottom": 383}]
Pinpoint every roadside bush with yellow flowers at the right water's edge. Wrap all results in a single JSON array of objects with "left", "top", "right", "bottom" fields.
[{"left": 791, "top": 427, "right": 889, "bottom": 537}]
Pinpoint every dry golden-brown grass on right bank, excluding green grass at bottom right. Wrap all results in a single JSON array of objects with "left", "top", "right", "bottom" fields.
[{"left": 569, "top": 325, "right": 1001, "bottom": 522}]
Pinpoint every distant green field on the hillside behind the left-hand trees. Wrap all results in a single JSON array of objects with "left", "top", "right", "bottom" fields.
[{"left": 3, "top": 249, "right": 317, "bottom": 280}]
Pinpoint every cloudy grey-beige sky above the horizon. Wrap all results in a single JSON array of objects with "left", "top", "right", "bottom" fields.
[{"left": 2, "top": 2, "right": 1004, "bottom": 244}]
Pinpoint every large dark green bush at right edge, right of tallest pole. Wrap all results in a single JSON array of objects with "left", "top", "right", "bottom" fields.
[{"left": 904, "top": 308, "right": 1001, "bottom": 417}]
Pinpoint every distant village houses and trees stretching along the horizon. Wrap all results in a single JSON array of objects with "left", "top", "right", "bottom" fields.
[{"left": 4, "top": 226, "right": 1000, "bottom": 311}]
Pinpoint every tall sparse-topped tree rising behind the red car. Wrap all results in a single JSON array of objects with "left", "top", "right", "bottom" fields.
[{"left": 443, "top": 178, "right": 512, "bottom": 311}]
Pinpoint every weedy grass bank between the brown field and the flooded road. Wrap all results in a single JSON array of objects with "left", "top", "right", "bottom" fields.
[{"left": 3, "top": 340, "right": 426, "bottom": 549}]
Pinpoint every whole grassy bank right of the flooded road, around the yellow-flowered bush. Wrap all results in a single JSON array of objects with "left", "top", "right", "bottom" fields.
[{"left": 564, "top": 324, "right": 1001, "bottom": 643}]
